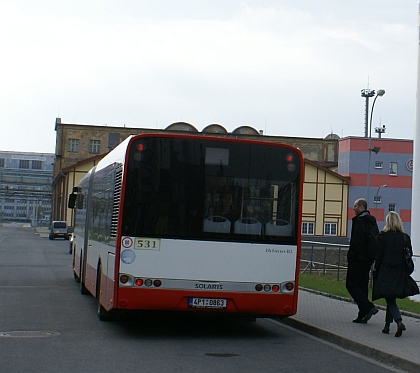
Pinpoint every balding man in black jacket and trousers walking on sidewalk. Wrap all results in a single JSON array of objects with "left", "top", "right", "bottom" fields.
[{"left": 346, "top": 198, "right": 379, "bottom": 324}]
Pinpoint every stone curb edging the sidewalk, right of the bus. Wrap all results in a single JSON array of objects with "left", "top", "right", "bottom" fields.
[{"left": 277, "top": 318, "right": 420, "bottom": 373}]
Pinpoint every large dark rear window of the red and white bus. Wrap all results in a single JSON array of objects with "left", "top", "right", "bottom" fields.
[{"left": 122, "top": 137, "right": 301, "bottom": 242}]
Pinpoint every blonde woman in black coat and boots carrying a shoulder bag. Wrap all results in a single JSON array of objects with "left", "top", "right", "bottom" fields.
[{"left": 372, "top": 211, "right": 419, "bottom": 337}]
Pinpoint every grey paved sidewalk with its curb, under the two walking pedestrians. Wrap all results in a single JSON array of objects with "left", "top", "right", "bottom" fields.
[{"left": 281, "top": 289, "right": 420, "bottom": 373}]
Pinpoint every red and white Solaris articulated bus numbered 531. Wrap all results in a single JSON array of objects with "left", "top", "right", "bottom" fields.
[{"left": 69, "top": 134, "right": 303, "bottom": 320}]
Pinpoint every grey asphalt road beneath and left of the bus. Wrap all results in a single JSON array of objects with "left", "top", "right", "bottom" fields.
[{"left": 0, "top": 224, "right": 406, "bottom": 373}]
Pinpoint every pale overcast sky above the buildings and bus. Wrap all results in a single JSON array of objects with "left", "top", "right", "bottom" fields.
[{"left": 0, "top": 0, "right": 419, "bottom": 153}]
